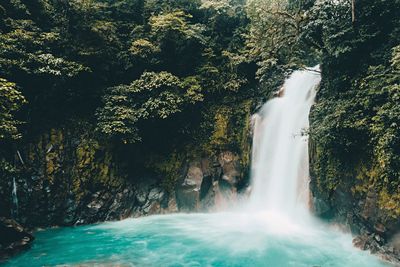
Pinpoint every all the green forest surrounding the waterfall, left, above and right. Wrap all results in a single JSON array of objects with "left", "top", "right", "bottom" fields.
[{"left": 0, "top": 0, "right": 400, "bottom": 222}]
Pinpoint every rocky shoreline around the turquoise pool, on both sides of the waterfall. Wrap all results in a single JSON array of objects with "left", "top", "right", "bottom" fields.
[{"left": 0, "top": 130, "right": 400, "bottom": 265}]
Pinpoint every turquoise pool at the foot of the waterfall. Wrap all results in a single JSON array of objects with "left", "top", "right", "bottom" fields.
[{"left": 5, "top": 213, "right": 386, "bottom": 267}]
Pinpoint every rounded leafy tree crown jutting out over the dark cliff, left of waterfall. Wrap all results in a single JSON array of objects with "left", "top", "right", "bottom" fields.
[{"left": 97, "top": 72, "right": 203, "bottom": 142}]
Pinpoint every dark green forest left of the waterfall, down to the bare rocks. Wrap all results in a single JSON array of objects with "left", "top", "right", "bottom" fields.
[{"left": 0, "top": 0, "right": 260, "bottom": 199}]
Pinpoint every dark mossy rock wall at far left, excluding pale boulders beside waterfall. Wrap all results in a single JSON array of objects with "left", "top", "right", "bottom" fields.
[{"left": 0, "top": 129, "right": 168, "bottom": 227}]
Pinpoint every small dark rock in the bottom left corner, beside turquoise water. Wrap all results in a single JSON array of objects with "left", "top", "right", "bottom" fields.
[{"left": 0, "top": 217, "right": 34, "bottom": 262}]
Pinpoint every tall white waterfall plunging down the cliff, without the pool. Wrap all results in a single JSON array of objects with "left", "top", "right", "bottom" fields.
[{"left": 250, "top": 66, "right": 321, "bottom": 217}]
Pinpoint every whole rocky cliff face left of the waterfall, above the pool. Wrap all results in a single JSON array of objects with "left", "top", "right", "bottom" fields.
[{"left": 0, "top": 127, "right": 244, "bottom": 228}]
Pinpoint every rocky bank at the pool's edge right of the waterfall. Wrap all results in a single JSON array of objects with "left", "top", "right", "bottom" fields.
[{"left": 309, "top": 140, "right": 400, "bottom": 264}]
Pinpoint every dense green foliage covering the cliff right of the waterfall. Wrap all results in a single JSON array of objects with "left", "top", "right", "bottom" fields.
[{"left": 304, "top": 0, "right": 400, "bottom": 220}]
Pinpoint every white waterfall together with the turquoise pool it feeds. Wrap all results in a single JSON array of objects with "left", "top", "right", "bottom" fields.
[{"left": 6, "top": 67, "right": 386, "bottom": 267}]
